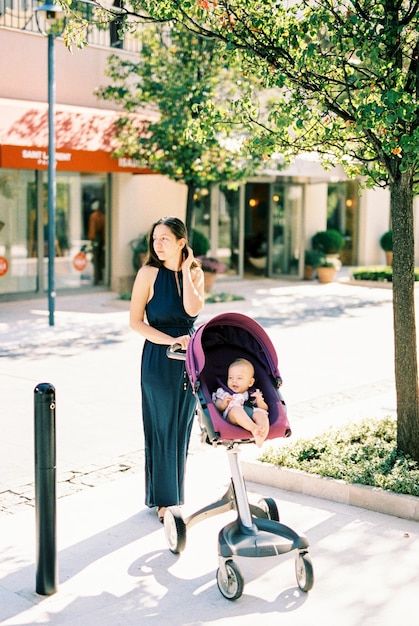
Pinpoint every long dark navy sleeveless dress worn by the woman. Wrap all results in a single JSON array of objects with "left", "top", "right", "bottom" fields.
[{"left": 141, "top": 266, "right": 196, "bottom": 507}]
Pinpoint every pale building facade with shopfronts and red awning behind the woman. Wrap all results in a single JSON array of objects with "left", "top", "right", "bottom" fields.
[{"left": 0, "top": 0, "right": 419, "bottom": 299}]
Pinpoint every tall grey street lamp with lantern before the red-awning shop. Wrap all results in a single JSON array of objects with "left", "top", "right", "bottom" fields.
[{"left": 35, "top": 2, "right": 65, "bottom": 326}]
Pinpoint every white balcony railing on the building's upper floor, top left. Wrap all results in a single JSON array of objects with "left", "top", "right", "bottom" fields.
[{"left": 0, "top": 0, "right": 140, "bottom": 52}]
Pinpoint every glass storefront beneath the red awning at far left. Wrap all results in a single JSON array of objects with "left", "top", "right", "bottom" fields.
[{"left": 0, "top": 169, "right": 108, "bottom": 295}]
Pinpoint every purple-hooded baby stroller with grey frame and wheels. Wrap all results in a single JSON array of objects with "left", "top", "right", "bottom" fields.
[{"left": 164, "top": 313, "right": 314, "bottom": 600}]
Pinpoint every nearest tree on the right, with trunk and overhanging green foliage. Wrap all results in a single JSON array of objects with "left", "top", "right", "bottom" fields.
[{"left": 66, "top": 0, "right": 419, "bottom": 461}]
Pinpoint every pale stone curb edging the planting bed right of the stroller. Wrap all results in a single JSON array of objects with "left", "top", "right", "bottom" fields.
[{"left": 240, "top": 461, "right": 419, "bottom": 522}]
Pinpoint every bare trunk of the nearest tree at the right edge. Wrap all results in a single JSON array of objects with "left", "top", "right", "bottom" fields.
[{"left": 390, "top": 172, "right": 419, "bottom": 462}]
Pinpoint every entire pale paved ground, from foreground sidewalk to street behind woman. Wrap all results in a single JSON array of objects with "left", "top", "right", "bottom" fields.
[{"left": 0, "top": 279, "right": 419, "bottom": 626}]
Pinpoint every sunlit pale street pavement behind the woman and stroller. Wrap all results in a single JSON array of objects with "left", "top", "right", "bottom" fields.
[{"left": 0, "top": 279, "right": 395, "bottom": 511}]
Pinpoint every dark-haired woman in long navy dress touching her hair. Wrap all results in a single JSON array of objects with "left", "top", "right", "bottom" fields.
[{"left": 130, "top": 217, "right": 204, "bottom": 522}]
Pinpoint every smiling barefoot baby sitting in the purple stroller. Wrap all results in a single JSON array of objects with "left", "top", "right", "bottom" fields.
[{"left": 212, "top": 358, "right": 269, "bottom": 448}]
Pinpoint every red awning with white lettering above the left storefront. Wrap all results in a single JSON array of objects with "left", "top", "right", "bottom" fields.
[{"left": 0, "top": 98, "right": 155, "bottom": 174}]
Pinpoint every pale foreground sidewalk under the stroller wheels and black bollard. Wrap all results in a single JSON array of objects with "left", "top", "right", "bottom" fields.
[{"left": 0, "top": 450, "right": 419, "bottom": 626}]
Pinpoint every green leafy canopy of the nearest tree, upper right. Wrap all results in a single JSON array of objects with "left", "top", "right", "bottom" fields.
[{"left": 66, "top": 0, "right": 419, "bottom": 184}]
